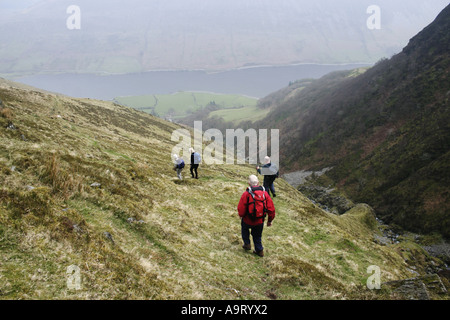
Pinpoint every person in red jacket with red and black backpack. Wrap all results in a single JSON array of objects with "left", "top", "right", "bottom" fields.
[{"left": 238, "top": 175, "right": 275, "bottom": 257}]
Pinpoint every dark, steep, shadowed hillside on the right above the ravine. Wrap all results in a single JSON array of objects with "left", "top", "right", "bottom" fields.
[{"left": 258, "top": 6, "right": 450, "bottom": 237}]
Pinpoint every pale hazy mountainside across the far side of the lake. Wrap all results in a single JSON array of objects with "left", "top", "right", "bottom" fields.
[{"left": 0, "top": 0, "right": 447, "bottom": 76}]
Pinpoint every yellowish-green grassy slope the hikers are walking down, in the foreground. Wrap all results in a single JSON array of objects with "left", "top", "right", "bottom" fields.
[{"left": 0, "top": 81, "right": 446, "bottom": 299}]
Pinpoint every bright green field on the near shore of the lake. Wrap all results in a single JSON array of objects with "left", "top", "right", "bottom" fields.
[{"left": 115, "top": 92, "right": 258, "bottom": 119}]
